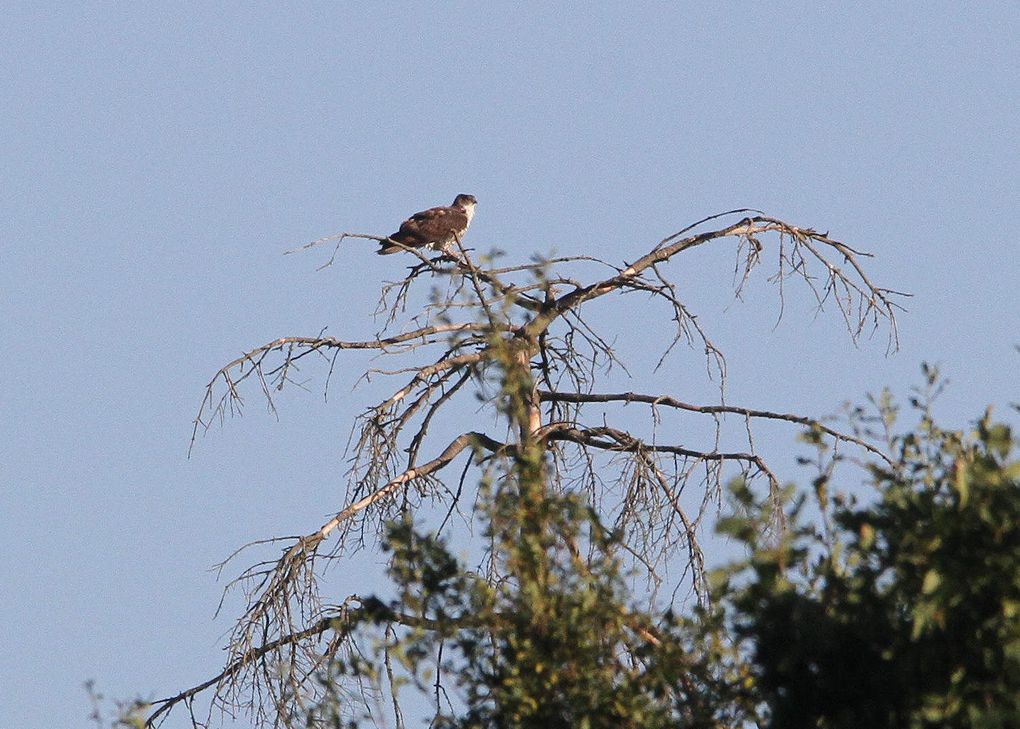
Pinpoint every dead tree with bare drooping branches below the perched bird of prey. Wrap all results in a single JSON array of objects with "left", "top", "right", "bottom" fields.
[{"left": 148, "top": 210, "right": 905, "bottom": 726}]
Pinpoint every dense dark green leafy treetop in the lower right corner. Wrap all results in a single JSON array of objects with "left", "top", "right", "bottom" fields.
[{"left": 715, "top": 387, "right": 1020, "bottom": 728}]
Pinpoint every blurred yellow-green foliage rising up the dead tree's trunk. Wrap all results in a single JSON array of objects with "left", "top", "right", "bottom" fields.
[{"left": 311, "top": 334, "right": 749, "bottom": 729}]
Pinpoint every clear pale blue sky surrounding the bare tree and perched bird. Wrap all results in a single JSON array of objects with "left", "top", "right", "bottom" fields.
[{"left": 0, "top": 2, "right": 1020, "bottom": 729}]
